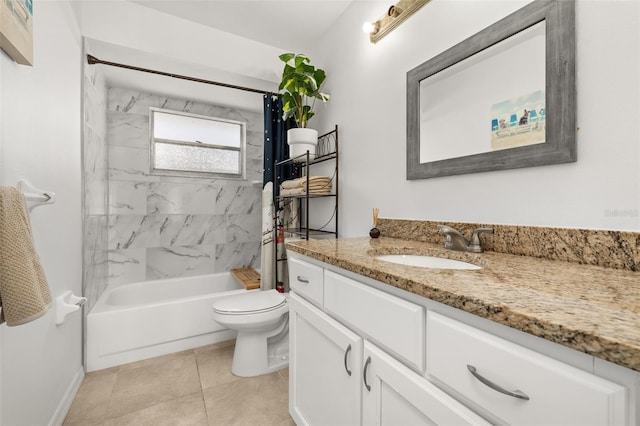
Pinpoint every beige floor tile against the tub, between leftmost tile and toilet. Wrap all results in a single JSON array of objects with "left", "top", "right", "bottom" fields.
[{"left": 107, "top": 352, "right": 201, "bottom": 418}]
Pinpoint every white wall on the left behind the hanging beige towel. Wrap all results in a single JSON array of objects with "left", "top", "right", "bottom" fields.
[{"left": 0, "top": 0, "right": 83, "bottom": 425}]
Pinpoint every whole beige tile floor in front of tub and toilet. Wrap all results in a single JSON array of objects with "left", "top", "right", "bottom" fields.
[{"left": 64, "top": 341, "right": 295, "bottom": 426}]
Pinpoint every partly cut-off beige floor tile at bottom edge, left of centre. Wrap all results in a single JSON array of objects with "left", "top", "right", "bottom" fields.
[{"left": 104, "top": 392, "right": 207, "bottom": 426}]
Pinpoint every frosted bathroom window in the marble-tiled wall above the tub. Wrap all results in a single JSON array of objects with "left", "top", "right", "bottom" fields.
[{"left": 150, "top": 108, "right": 246, "bottom": 178}]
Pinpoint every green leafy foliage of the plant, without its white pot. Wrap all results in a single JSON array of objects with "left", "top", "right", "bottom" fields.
[{"left": 278, "top": 53, "right": 329, "bottom": 127}]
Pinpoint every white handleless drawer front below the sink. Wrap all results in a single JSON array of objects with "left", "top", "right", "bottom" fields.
[{"left": 324, "top": 271, "right": 424, "bottom": 372}]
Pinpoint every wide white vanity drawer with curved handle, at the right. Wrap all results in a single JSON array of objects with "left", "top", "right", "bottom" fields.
[{"left": 426, "top": 311, "right": 626, "bottom": 425}]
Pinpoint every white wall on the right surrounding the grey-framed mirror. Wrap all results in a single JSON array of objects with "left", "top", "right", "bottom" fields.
[{"left": 312, "top": 0, "right": 640, "bottom": 236}]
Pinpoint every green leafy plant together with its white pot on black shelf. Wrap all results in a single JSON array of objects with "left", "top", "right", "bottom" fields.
[{"left": 278, "top": 53, "right": 329, "bottom": 158}]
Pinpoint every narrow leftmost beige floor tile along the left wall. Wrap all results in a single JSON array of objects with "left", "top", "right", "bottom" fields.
[{"left": 64, "top": 372, "right": 117, "bottom": 425}]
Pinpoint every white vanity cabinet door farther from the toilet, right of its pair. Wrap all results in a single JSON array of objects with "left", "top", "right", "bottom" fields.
[{"left": 362, "top": 341, "right": 489, "bottom": 426}]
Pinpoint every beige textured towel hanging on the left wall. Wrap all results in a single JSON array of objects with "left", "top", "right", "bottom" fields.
[{"left": 0, "top": 187, "right": 53, "bottom": 326}]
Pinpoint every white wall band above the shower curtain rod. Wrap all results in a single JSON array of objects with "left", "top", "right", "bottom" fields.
[{"left": 77, "top": 0, "right": 283, "bottom": 86}]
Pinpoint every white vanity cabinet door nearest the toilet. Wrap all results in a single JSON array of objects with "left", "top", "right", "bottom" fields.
[{"left": 289, "top": 293, "right": 362, "bottom": 426}]
